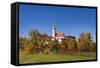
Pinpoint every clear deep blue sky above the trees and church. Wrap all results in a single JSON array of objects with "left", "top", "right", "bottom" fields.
[{"left": 19, "top": 4, "right": 96, "bottom": 40}]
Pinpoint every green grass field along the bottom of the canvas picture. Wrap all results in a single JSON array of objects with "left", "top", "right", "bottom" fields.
[{"left": 19, "top": 53, "right": 96, "bottom": 64}]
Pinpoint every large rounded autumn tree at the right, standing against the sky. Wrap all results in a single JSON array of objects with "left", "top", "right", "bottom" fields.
[{"left": 78, "top": 32, "right": 93, "bottom": 51}]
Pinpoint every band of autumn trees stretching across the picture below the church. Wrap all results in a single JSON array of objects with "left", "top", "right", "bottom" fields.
[{"left": 19, "top": 30, "right": 96, "bottom": 54}]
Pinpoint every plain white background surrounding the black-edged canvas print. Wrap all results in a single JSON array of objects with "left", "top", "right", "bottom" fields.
[{"left": 0, "top": 0, "right": 100, "bottom": 68}]
